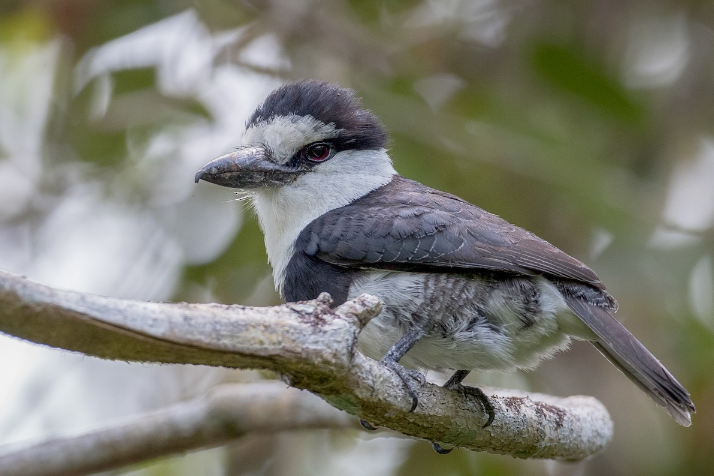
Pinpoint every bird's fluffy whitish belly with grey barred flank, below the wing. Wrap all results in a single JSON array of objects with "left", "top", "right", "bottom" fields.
[{"left": 349, "top": 271, "right": 569, "bottom": 370}]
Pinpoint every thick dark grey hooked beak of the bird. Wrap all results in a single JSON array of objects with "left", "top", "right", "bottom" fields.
[{"left": 196, "top": 147, "right": 301, "bottom": 188}]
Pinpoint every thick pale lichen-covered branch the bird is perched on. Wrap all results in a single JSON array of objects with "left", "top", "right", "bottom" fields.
[{"left": 0, "top": 272, "right": 612, "bottom": 459}]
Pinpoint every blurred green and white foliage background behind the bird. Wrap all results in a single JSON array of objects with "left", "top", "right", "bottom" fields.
[{"left": 0, "top": 0, "right": 714, "bottom": 475}]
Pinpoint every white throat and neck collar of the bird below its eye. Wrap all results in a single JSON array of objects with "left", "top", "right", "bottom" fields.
[{"left": 253, "top": 149, "right": 397, "bottom": 295}]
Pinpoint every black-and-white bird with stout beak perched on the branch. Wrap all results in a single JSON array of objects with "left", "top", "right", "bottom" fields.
[{"left": 195, "top": 80, "right": 695, "bottom": 453}]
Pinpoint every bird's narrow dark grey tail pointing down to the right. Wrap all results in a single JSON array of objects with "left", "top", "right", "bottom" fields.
[{"left": 566, "top": 297, "right": 695, "bottom": 426}]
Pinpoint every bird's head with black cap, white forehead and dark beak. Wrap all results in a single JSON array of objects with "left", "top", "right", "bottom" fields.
[{"left": 196, "top": 81, "right": 394, "bottom": 191}]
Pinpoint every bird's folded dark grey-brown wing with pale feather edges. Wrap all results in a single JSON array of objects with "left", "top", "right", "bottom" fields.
[{"left": 296, "top": 176, "right": 605, "bottom": 291}]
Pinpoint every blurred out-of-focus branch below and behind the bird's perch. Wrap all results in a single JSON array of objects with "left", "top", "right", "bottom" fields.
[{"left": 0, "top": 382, "right": 355, "bottom": 476}]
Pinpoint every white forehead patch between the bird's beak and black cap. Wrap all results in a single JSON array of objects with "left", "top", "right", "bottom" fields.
[{"left": 242, "top": 114, "right": 340, "bottom": 164}]
